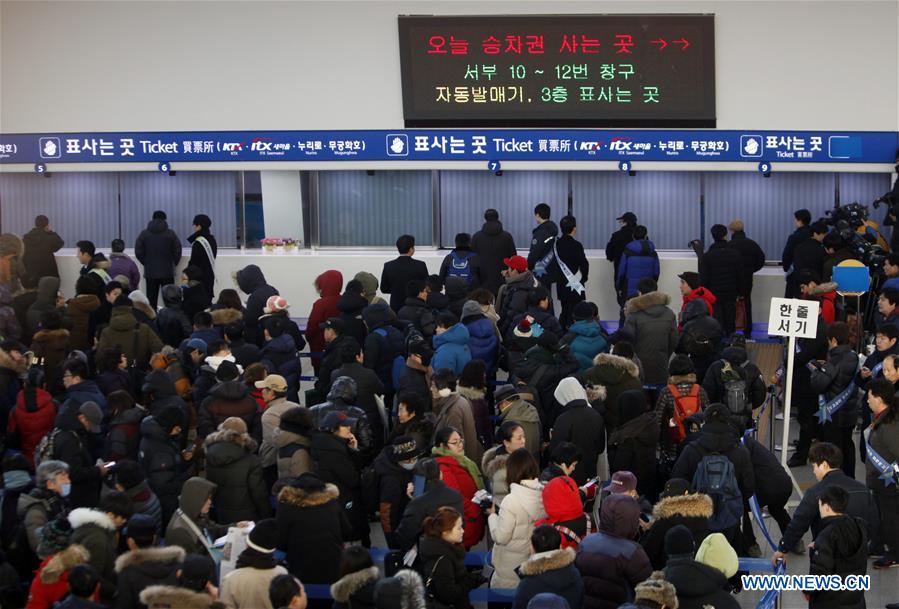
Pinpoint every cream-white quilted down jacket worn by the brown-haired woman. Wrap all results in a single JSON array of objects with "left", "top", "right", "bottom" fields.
[{"left": 487, "top": 480, "right": 546, "bottom": 588}]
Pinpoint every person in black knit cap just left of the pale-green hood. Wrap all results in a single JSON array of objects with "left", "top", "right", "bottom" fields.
[{"left": 664, "top": 524, "right": 740, "bottom": 609}]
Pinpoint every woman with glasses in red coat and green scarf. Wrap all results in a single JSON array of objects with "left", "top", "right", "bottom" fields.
[{"left": 431, "top": 427, "right": 486, "bottom": 550}]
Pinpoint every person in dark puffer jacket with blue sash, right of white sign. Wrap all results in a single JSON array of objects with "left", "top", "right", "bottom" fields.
[{"left": 809, "top": 321, "right": 858, "bottom": 477}]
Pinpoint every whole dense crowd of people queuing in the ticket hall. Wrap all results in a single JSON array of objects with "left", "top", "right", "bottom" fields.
[{"left": 0, "top": 204, "right": 899, "bottom": 609}]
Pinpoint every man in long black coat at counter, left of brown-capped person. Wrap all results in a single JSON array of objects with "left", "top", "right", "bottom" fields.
[{"left": 699, "top": 224, "right": 744, "bottom": 336}]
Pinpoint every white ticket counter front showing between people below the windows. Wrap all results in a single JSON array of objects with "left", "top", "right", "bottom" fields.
[{"left": 57, "top": 250, "right": 784, "bottom": 323}]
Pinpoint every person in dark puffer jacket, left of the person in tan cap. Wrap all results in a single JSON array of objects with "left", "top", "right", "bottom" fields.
[{"left": 197, "top": 360, "right": 262, "bottom": 443}]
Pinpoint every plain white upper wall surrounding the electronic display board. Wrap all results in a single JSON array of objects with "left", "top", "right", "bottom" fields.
[{"left": 0, "top": 0, "right": 899, "bottom": 133}]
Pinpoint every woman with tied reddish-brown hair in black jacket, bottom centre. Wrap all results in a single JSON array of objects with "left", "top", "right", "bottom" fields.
[{"left": 418, "top": 507, "right": 482, "bottom": 609}]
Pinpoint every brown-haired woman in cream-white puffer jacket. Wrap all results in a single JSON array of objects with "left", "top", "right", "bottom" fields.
[{"left": 487, "top": 448, "right": 546, "bottom": 588}]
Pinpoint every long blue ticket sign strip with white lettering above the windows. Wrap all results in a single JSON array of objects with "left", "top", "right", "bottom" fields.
[{"left": 0, "top": 129, "right": 899, "bottom": 164}]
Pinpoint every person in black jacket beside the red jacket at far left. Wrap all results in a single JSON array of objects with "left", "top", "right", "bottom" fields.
[{"left": 51, "top": 401, "right": 107, "bottom": 508}]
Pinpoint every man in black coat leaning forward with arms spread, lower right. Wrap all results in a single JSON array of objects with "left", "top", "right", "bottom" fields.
[{"left": 771, "top": 442, "right": 880, "bottom": 561}]
